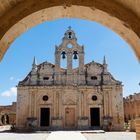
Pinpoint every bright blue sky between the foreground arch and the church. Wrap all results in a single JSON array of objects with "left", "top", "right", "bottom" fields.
[{"left": 0, "top": 18, "right": 140, "bottom": 105}]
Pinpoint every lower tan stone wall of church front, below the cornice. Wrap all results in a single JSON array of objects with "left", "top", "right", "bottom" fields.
[{"left": 17, "top": 86, "right": 123, "bottom": 130}]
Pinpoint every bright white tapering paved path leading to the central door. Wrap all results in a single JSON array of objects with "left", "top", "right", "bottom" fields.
[{"left": 46, "top": 131, "right": 87, "bottom": 140}]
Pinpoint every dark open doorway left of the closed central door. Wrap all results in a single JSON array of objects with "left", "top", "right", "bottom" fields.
[{"left": 40, "top": 108, "right": 50, "bottom": 127}]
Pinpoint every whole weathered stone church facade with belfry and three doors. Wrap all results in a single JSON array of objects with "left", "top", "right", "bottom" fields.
[{"left": 16, "top": 28, "right": 124, "bottom": 130}]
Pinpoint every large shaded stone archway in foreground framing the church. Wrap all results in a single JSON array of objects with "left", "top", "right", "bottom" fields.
[{"left": 0, "top": 0, "right": 140, "bottom": 61}]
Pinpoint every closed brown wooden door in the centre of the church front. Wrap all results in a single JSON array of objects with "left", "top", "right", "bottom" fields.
[{"left": 65, "top": 108, "right": 75, "bottom": 129}]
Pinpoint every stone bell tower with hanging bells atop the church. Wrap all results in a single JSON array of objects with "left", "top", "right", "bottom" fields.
[{"left": 55, "top": 27, "right": 84, "bottom": 85}]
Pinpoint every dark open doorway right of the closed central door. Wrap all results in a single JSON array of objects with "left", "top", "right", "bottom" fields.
[{"left": 90, "top": 108, "right": 100, "bottom": 126}]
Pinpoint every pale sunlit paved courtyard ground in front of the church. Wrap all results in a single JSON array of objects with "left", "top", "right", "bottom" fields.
[{"left": 0, "top": 126, "right": 136, "bottom": 140}]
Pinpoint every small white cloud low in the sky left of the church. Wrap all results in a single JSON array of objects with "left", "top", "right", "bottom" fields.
[{"left": 1, "top": 87, "right": 17, "bottom": 97}]
